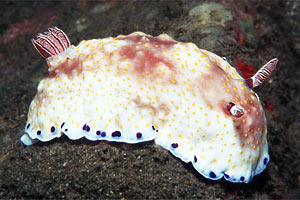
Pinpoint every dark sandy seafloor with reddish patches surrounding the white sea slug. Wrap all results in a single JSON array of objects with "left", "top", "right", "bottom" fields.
[{"left": 0, "top": 0, "right": 300, "bottom": 199}]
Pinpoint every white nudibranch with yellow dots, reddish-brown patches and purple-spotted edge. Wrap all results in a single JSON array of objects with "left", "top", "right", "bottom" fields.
[{"left": 21, "top": 27, "right": 278, "bottom": 183}]
